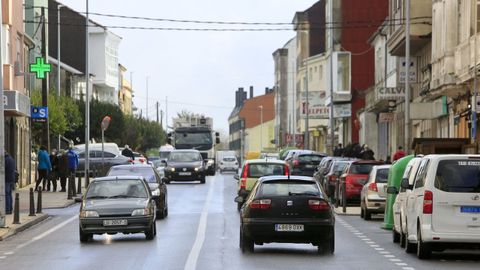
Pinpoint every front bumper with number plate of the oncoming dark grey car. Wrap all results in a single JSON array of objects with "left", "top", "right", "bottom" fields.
[{"left": 80, "top": 215, "right": 155, "bottom": 234}]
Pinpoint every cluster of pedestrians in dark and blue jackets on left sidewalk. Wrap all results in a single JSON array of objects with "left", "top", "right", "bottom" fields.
[{"left": 35, "top": 146, "right": 78, "bottom": 192}]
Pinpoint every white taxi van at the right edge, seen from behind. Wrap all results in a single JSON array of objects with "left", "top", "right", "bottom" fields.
[{"left": 402, "top": 154, "right": 480, "bottom": 259}]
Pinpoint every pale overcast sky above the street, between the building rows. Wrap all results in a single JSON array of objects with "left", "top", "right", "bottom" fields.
[{"left": 59, "top": 0, "right": 317, "bottom": 134}]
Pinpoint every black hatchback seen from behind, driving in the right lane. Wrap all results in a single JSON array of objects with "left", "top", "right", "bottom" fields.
[{"left": 236, "top": 176, "right": 335, "bottom": 254}]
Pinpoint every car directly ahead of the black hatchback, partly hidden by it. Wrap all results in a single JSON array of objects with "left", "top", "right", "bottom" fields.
[{"left": 234, "top": 159, "right": 290, "bottom": 210}]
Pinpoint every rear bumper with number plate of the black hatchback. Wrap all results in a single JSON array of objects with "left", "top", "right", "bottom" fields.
[{"left": 242, "top": 219, "right": 334, "bottom": 245}]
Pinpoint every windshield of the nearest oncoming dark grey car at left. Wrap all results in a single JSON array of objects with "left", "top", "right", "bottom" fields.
[{"left": 85, "top": 179, "right": 148, "bottom": 199}]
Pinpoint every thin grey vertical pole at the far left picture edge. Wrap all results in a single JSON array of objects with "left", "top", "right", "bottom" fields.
[{"left": 0, "top": 1, "right": 6, "bottom": 228}]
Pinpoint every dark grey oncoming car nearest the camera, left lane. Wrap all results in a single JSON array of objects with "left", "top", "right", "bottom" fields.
[{"left": 79, "top": 176, "right": 157, "bottom": 242}]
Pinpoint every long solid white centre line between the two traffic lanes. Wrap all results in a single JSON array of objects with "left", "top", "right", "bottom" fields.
[{"left": 184, "top": 177, "right": 216, "bottom": 270}]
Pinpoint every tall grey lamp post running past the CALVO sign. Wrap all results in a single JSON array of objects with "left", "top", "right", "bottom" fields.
[{"left": 405, "top": 0, "right": 411, "bottom": 153}]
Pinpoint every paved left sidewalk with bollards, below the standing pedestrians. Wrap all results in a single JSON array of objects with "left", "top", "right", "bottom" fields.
[{"left": 0, "top": 181, "right": 84, "bottom": 241}]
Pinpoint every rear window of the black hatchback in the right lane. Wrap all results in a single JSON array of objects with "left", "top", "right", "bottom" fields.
[{"left": 259, "top": 180, "right": 320, "bottom": 196}]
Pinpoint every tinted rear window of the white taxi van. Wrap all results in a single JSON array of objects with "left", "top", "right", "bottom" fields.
[{"left": 435, "top": 159, "right": 480, "bottom": 192}]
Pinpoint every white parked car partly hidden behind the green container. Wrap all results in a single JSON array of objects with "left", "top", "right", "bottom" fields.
[{"left": 360, "top": 165, "right": 391, "bottom": 220}]
